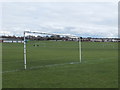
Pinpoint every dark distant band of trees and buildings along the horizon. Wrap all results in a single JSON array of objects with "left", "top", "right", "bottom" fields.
[{"left": 1, "top": 35, "right": 120, "bottom": 42}]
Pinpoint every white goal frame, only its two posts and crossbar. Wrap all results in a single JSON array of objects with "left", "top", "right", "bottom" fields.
[{"left": 24, "top": 31, "right": 82, "bottom": 70}]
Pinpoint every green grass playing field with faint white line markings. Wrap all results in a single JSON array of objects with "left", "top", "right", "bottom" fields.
[{"left": 2, "top": 41, "right": 118, "bottom": 88}]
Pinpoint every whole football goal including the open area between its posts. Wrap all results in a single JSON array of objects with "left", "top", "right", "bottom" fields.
[{"left": 24, "top": 31, "right": 81, "bottom": 69}]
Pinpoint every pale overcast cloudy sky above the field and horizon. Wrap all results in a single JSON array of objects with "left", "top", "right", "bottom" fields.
[{"left": 0, "top": 2, "right": 118, "bottom": 37}]
